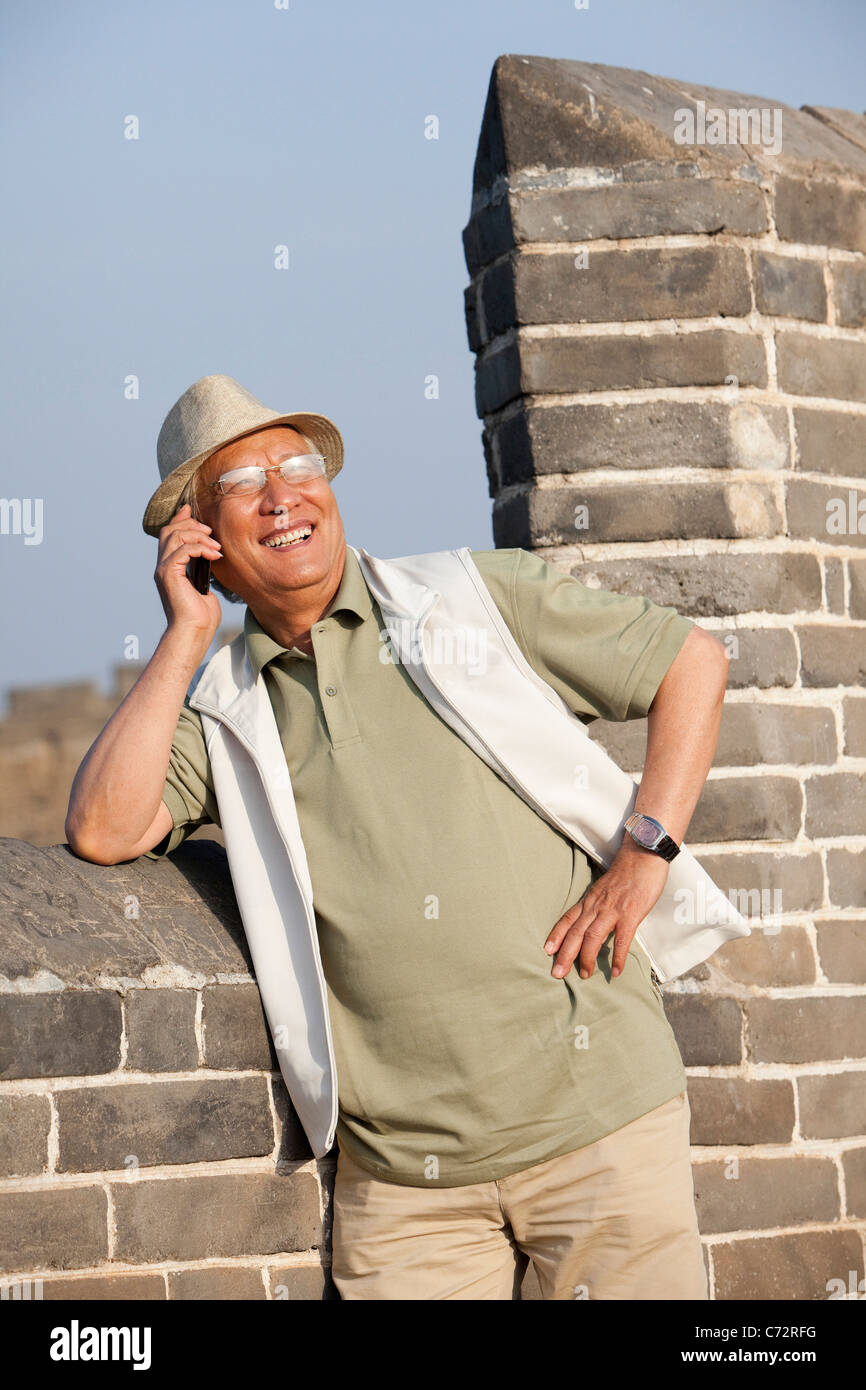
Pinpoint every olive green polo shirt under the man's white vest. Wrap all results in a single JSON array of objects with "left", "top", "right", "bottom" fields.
[{"left": 150, "top": 549, "right": 692, "bottom": 1187}]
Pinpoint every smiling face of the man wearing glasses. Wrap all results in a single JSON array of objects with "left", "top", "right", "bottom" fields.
[{"left": 196, "top": 425, "right": 346, "bottom": 609}]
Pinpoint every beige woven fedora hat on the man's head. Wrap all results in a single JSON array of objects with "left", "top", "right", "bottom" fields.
[{"left": 142, "top": 375, "right": 343, "bottom": 538}]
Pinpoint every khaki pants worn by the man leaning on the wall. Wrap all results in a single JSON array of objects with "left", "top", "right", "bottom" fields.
[{"left": 331, "top": 1091, "right": 708, "bottom": 1300}]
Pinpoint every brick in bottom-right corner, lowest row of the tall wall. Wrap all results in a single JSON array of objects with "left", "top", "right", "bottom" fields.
[{"left": 713, "top": 1230, "right": 863, "bottom": 1302}]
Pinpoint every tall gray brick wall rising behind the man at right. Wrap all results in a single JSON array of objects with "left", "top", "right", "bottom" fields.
[{"left": 464, "top": 56, "right": 866, "bottom": 1300}]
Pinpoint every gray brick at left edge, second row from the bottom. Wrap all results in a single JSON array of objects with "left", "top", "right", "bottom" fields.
[{"left": 0, "top": 1187, "right": 108, "bottom": 1273}]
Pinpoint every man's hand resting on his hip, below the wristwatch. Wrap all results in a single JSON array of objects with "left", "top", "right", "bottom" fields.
[{"left": 545, "top": 837, "right": 669, "bottom": 980}]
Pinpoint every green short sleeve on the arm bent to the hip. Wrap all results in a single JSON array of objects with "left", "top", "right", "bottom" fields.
[{"left": 471, "top": 549, "right": 695, "bottom": 723}]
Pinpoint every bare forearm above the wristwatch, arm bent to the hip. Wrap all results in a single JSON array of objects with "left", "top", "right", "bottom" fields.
[{"left": 624, "top": 634, "right": 728, "bottom": 855}]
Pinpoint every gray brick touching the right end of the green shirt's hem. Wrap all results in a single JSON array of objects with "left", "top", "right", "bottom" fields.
[{"left": 688, "top": 1076, "right": 795, "bottom": 1145}]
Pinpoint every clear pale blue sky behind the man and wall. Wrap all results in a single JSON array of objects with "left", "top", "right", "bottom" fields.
[{"left": 0, "top": 0, "right": 866, "bottom": 689}]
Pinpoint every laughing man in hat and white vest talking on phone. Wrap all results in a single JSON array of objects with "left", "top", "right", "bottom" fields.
[{"left": 67, "top": 375, "right": 740, "bottom": 1300}]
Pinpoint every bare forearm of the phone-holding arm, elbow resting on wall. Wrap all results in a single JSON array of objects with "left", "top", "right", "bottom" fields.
[{"left": 65, "top": 627, "right": 210, "bottom": 855}]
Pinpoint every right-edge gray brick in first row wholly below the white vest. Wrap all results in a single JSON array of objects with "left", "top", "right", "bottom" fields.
[{"left": 746, "top": 995, "right": 866, "bottom": 1062}]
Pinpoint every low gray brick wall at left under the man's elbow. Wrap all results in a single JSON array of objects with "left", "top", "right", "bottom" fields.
[{"left": 0, "top": 840, "right": 336, "bottom": 1300}]
